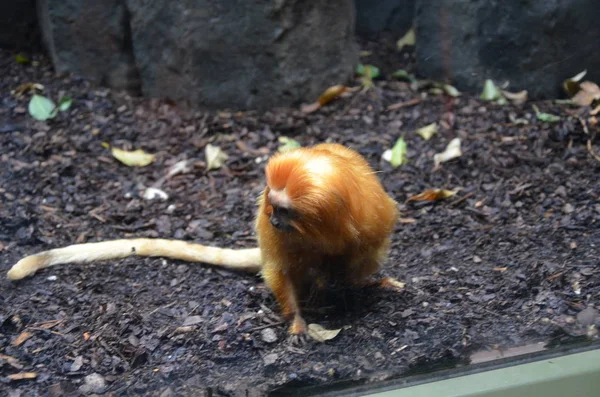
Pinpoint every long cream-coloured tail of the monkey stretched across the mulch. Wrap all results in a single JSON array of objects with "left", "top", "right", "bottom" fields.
[{"left": 6, "top": 238, "right": 261, "bottom": 280}]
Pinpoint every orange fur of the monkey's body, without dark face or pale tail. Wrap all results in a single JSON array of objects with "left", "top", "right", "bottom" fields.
[{"left": 256, "top": 144, "right": 398, "bottom": 333}]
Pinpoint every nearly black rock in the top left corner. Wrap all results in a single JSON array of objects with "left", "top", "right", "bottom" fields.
[{"left": 0, "top": 0, "right": 40, "bottom": 50}]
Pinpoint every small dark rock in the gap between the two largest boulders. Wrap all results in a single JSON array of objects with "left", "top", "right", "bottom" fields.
[{"left": 354, "top": 0, "right": 416, "bottom": 36}]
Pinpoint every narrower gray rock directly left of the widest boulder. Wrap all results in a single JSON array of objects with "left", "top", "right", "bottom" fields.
[{"left": 37, "top": 0, "right": 139, "bottom": 93}]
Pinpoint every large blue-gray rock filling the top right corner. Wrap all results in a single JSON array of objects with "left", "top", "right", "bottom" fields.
[{"left": 415, "top": 0, "right": 600, "bottom": 99}]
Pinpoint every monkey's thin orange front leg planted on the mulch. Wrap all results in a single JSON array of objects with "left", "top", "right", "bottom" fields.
[{"left": 262, "top": 263, "right": 306, "bottom": 335}]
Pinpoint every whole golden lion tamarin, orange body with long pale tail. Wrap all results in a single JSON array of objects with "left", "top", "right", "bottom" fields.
[{"left": 7, "top": 144, "right": 401, "bottom": 334}]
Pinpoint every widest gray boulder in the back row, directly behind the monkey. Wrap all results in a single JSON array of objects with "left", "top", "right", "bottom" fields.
[{"left": 127, "top": 0, "right": 358, "bottom": 109}]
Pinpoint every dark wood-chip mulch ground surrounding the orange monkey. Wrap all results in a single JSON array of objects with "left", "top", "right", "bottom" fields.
[{"left": 0, "top": 43, "right": 600, "bottom": 397}]
